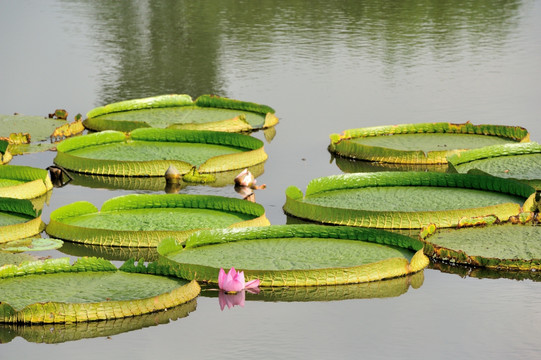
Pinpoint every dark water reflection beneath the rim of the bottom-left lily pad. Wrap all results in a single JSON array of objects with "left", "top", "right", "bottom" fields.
[{"left": 0, "top": 299, "right": 197, "bottom": 344}]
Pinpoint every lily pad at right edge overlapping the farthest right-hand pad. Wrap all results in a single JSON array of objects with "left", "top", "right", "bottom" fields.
[{"left": 448, "top": 143, "right": 541, "bottom": 190}]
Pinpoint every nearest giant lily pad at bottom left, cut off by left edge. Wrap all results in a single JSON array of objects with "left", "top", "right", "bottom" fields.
[{"left": 0, "top": 258, "right": 200, "bottom": 323}]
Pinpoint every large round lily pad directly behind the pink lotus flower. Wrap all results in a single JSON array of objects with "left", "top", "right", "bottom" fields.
[{"left": 158, "top": 225, "right": 428, "bottom": 287}]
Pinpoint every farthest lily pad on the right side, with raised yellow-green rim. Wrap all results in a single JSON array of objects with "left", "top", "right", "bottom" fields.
[{"left": 329, "top": 122, "right": 530, "bottom": 164}]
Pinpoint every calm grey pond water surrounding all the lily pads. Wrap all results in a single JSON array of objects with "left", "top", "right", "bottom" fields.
[{"left": 0, "top": 0, "right": 541, "bottom": 360}]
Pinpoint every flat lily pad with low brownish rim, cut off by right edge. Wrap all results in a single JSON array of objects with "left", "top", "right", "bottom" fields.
[{"left": 424, "top": 223, "right": 541, "bottom": 270}]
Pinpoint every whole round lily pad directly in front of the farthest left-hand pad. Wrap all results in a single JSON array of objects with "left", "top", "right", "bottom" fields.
[{"left": 54, "top": 129, "right": 267, "bottom": 176}]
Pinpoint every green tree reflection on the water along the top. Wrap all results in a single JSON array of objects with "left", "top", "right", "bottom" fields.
[{"left": 62, "top": 0, "right": 521, "bottom": 104}]
